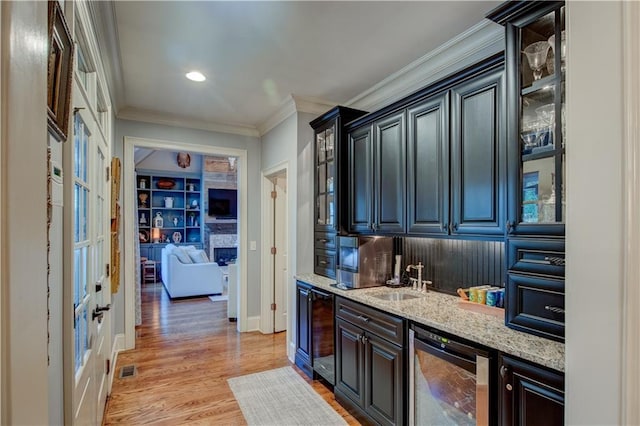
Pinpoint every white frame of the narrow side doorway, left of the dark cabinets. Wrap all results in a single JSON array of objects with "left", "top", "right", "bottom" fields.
[{"left": 260, "top": 161, "right": 293, "bottom": 334}]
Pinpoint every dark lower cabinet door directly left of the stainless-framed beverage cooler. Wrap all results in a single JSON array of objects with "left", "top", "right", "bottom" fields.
[{"left": 364, "top": 333, "right": 404, "bottom": 425}]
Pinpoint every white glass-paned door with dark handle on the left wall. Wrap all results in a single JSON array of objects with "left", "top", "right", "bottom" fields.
[{"left": 70, "top": 92, "right": 111, "bottom": 425}]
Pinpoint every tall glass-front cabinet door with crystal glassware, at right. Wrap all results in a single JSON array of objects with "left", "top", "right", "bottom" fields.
[{"left": 507, "top": 2, "right": 567, "bottom": 236}]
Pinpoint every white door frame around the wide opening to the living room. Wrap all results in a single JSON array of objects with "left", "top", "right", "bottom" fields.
[{"left": 122, "top": 136, "right": 248, "bottom": 349}]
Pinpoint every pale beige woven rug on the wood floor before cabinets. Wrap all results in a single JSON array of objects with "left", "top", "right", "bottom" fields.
[{"left": 227, "top": 367, "right": 347, "bottom": 426}]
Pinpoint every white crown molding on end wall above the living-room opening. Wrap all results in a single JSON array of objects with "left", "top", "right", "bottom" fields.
[{"left": 117, "top": 107, "right": 260, "bottom": 138}]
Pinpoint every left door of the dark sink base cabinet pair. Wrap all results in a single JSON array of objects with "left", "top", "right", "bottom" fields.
[{"left": 335, "top": 318, "right": 365, "bottom": 407}]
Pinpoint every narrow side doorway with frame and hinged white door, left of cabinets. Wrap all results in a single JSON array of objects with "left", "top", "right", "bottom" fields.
[{"left": 260, "top": 165, "right": 291, "bottom": 333}]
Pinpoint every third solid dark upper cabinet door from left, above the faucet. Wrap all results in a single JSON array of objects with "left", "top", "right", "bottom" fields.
[{"left": 407, "top": 92, "right": 449, "bottom": 235}]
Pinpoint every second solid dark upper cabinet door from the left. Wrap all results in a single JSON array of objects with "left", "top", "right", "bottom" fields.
[{"left": 373, "top": 111, "right": 407, "bottom": 233}]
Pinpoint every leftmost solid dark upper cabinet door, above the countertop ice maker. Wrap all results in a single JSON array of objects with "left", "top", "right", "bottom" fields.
[{"left": 347, "top": 125, "right": 373, "bottom": 233}]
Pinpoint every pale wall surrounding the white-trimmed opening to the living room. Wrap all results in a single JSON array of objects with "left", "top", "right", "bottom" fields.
[{"left": 112, "top": 120, "right": 261, "bottom": 333}]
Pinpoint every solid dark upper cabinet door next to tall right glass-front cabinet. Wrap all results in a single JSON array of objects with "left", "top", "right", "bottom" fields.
[{"left": 450, "top": 70, "right": 506, "bottom": 235}]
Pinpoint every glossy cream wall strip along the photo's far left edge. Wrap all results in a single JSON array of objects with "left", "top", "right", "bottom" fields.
[{"left": 0, "top": 2, "right": 49, "bottom": 425}]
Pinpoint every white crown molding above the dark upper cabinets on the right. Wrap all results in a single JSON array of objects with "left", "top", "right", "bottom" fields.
[{"left": 344, "top": 19, "right": 504, "bottom": 111}]
